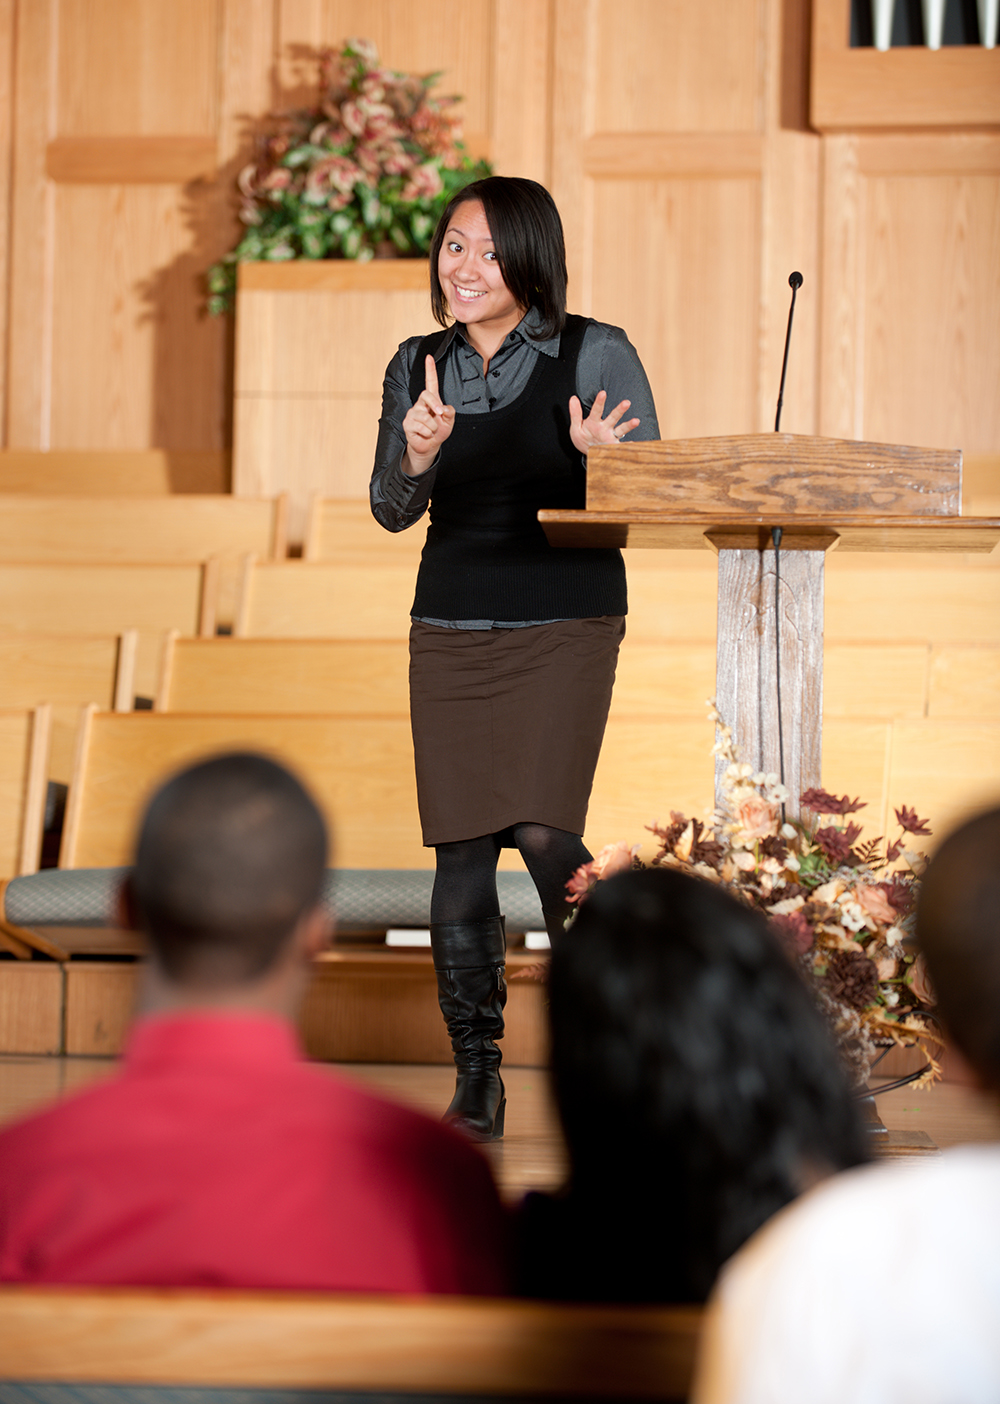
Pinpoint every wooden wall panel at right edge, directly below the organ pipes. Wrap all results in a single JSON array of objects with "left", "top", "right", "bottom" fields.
[{"left": 820, "top": 132, "right": 1000, "bottom": 453}]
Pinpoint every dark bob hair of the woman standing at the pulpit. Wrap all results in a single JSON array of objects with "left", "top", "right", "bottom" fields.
[{"left": 430, "top": 176, "right": 566, "bottom": 341}]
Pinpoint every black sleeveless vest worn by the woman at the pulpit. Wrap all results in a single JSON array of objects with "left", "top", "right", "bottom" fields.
[{"left": 410, "top": 316, "right": 628, "bottom": 622}]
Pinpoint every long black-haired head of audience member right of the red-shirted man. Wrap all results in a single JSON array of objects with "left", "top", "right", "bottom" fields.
[{"left": 549, "top": 869, "right": 867, "bottom": 1296}]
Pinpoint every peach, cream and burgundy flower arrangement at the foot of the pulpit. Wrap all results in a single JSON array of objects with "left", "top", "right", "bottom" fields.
[{"left": 567, "top": 706, "right": 941, "bottom": 1085}]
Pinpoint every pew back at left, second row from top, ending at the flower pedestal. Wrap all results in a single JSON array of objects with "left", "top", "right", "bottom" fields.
[{"left": 0, "top": 493, "right": 288, "bottom": 564}]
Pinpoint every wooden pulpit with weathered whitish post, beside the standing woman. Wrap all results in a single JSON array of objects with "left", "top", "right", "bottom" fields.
[{"left": 538, "top": 434, "right": 1000, "bottom": 814}]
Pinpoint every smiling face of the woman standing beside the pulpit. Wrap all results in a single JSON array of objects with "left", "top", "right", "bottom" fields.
[{"left": 438, "top": 199, "right": 525, "bottom": 355}]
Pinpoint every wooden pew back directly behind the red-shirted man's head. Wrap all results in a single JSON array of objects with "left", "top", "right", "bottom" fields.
[{"left": 59, "top": 708, "right": 428, "bottom": 868}]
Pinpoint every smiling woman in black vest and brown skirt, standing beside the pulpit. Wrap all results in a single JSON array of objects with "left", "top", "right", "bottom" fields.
[{"left": 371, "top": 176, "right": 659, "bottom": 1140}]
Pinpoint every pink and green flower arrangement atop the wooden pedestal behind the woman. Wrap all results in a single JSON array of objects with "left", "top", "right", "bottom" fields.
[{"left": 208, "top": 39, "right": 492, "bottom": 313}]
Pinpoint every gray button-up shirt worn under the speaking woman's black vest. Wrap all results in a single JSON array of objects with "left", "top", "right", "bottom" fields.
[{"left": 371, "top": 307, "right": 660, "bottom": 629}]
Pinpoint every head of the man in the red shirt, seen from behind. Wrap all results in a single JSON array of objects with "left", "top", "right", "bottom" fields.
[{"left": 131, "top": 753, "right": 327, "bottom": 987}]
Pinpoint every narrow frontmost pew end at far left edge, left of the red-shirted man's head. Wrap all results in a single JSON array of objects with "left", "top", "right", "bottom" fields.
[{"left": 0, "top": 706, "right": 52, "bottom": 881}]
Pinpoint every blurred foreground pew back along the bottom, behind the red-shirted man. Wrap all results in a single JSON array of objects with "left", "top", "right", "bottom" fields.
[{"left": 0, "top": 1286, "right": 702, "bottom": 1400}]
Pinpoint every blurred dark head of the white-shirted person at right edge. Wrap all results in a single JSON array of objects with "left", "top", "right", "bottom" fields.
[{"left": 917, "top": 809, "right": 1000, "bottom": 1091}]
